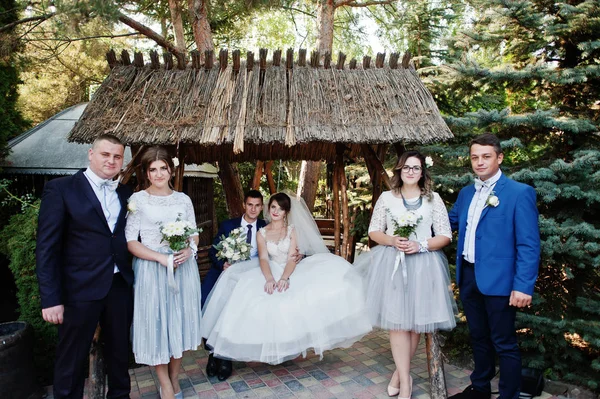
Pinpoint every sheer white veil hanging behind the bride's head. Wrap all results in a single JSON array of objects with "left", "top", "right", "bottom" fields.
[{"left": 264, "top": 192, "right": 329, "bottom": 255}]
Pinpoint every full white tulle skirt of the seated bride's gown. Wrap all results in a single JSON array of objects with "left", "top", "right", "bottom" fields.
[{"left": 201, "top": 254, "right": 371, "bottom": 364}]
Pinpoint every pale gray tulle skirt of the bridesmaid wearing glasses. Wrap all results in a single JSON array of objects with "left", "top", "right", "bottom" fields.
[{"left": 354, "top": 245, "right": 458, "bottom": 333}]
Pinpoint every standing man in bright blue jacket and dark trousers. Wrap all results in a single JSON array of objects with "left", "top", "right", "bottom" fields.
[{"left": 449, "top": 134, "right": 540, "bottom": 399}]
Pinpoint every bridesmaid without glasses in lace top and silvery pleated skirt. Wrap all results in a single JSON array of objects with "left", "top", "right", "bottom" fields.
[{"left": 125, "top": 147, "right": 202, "bottom": 399}]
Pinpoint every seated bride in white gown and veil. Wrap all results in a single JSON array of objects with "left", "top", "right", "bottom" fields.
[{"left": 200, "top": 193, "right": 371, "bottom": 364}]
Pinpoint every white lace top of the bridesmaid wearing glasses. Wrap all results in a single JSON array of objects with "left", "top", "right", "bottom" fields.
[{"left": 369, "top": 191, "right": 452, "bottom": 240}]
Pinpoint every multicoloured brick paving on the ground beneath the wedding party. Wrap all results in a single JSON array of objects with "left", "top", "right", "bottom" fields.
[{"left": 47, "top": 331, "right": 556, "bottom": 399}]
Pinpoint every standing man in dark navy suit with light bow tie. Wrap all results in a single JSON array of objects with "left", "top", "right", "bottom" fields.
[{"left": 36, "top": 135, "right": 133, "bottom": 399}]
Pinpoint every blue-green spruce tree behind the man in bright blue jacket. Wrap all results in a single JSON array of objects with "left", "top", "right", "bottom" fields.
[{"left": 425, "top": 0, "right": 600, "bottom": 389}]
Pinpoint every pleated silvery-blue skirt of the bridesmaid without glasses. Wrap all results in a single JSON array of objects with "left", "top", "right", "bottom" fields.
[{"left": 132, "top": 252, "right": 202, "bottom": 366}]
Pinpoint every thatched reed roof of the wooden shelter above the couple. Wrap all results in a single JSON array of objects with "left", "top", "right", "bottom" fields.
[{"left": 70, "top": 50, "right": 452, "bottom": 161}]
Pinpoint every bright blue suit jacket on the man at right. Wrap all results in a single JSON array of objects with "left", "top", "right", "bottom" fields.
[{"left": 449, "top": 174, "right": 540, "bottom": 296}]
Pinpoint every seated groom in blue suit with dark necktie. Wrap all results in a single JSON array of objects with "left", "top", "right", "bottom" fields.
[{"left": 202, "top": 190, "right": 267, "bottom": 381}]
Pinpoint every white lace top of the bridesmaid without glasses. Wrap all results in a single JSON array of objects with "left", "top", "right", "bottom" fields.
[{"left": 125, "top": 191, "right": 196, "bottom": 250}]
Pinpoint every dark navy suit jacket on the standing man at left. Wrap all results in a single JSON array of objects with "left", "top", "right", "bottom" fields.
[{"left": 36, "top": 169, "right": 133, "bottom": 309}]
